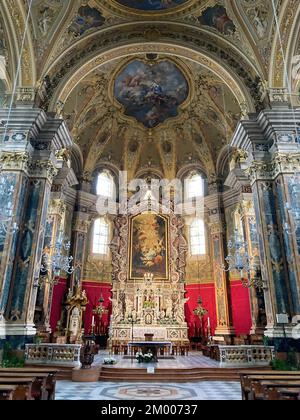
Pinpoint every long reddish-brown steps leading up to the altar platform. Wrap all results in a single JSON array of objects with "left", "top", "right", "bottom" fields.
[{"left": 99, "top": 367, "right": 253, "bottom": 382}]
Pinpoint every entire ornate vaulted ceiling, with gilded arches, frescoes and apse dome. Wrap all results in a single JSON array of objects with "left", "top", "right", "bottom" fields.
[{"left": 0, "top": 0, "right": 300, "bottom": 179}]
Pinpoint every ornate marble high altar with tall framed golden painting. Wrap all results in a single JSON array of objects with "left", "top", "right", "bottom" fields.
[{"left": 111, "top": 202, "right": 188, "bottom": 345}]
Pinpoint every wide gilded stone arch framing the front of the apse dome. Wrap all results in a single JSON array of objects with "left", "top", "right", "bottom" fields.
[{"left": 39, "top": 22, "right": 260, "bottom": 112}]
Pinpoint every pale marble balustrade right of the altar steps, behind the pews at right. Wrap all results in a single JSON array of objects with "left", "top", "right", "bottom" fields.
[{"left": 219, "top": 346, "right": 275, "bottom": 367}]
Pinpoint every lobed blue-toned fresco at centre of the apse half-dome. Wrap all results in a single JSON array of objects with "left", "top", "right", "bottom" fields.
[{"left": 114, "top": 60, "right": 189, "bottom": 128}]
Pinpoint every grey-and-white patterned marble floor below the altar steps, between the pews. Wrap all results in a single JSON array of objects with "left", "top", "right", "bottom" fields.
[{"left": 56, "top": 381, "right": 242, "bottom": 401}]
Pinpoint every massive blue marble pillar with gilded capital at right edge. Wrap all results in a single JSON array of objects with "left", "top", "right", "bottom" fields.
[{"left": 232, "top": 107, "right": 300, "bottom": 342}]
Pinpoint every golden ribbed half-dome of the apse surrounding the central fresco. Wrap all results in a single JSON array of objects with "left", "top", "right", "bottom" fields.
[{"left": 64, "top": 55, "right": 241, "bottom": 179}]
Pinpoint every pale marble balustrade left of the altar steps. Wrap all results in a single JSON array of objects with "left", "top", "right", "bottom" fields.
[{"left": 25, "top": 344, "right": 81, "bottom": 367}]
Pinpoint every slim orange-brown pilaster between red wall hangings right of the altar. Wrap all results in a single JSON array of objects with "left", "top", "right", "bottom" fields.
[{"left": 210, "top": 204, "right": 235, "bottom": 337}]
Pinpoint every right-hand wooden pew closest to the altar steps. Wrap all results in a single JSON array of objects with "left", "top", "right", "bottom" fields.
[{"left": 240, "top": 371, "right": 300, "bottom": 400}]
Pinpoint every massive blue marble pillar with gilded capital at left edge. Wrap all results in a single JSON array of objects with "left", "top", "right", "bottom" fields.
[{"left": 0, "top": 107, "right": 72, "bottom": 346}]
